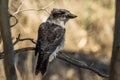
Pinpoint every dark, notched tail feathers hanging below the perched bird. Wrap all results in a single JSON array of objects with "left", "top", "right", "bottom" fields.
[{"left": 35, "top": 55, "right": 49, "bottom": 75}]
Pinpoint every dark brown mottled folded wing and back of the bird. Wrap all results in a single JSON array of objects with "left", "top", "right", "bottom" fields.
[{"left": 35, "top": 22, "right": 65, "bottom": 54}]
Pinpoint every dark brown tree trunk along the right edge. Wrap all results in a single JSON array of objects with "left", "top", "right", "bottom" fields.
[{"left": 109, "top": 0, "right": 120, "bottom": 80}]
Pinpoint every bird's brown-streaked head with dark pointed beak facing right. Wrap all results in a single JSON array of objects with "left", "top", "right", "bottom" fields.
[{"left": 48, "top": 8, "right": 77, "bottom": 24}]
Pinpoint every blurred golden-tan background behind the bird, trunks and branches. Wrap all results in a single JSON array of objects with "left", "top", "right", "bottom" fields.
[{"left": 0, "top": 0, "right": 115, "bottom": 80}]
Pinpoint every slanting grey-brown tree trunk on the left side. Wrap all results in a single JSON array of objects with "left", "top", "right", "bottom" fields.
[{"left": 0, "top": 0, "right": 17, "bottom": 80}]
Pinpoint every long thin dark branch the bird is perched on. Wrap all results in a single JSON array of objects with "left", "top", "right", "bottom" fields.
[{"left": 0, "top": 47, "right": 109, "bottom": 78}]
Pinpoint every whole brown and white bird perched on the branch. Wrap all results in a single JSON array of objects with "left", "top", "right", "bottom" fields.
[{"left": 35, "top": 8, "right": 77, "bottom": 75}]
